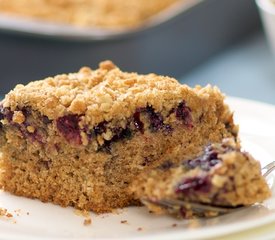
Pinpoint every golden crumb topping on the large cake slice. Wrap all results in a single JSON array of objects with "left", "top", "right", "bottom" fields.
[{"left": 3, "top": 61, "right": 224, "bottom": 126}]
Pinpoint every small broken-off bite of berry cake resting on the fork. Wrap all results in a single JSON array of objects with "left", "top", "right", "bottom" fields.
[{"left": 132, "top": 139, "right": 271, "bottom": 218}]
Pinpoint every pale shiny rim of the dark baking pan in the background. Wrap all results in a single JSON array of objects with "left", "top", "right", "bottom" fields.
[{"left": 0, "top": 0, "right": 202, "bottom": 40}]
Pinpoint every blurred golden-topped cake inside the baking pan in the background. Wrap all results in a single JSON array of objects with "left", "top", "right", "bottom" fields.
[{"left": 0, "top": 0, "right": 182, "bottom": 28}]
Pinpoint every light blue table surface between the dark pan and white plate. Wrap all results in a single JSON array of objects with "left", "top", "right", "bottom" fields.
[{"left": 180, "top": 33, "right": 275, "bottom": 104}]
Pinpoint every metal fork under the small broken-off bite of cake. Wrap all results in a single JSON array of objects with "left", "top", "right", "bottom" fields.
[{"left": 141, "top": 161, "right": 275, "bottom": 215}]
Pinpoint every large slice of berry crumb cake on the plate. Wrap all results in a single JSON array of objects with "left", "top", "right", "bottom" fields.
[{"left": 0, "top": 61, "right": 237, "bottom": 212}]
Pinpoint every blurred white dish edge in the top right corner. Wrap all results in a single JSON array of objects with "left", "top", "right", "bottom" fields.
[{"left": 256, "top": 0, "right": 275, "bottom": 54}]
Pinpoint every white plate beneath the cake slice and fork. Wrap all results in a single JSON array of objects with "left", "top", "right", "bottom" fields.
[{"left": 0, "top": 98, "right": 275, "bottom": 240}]
